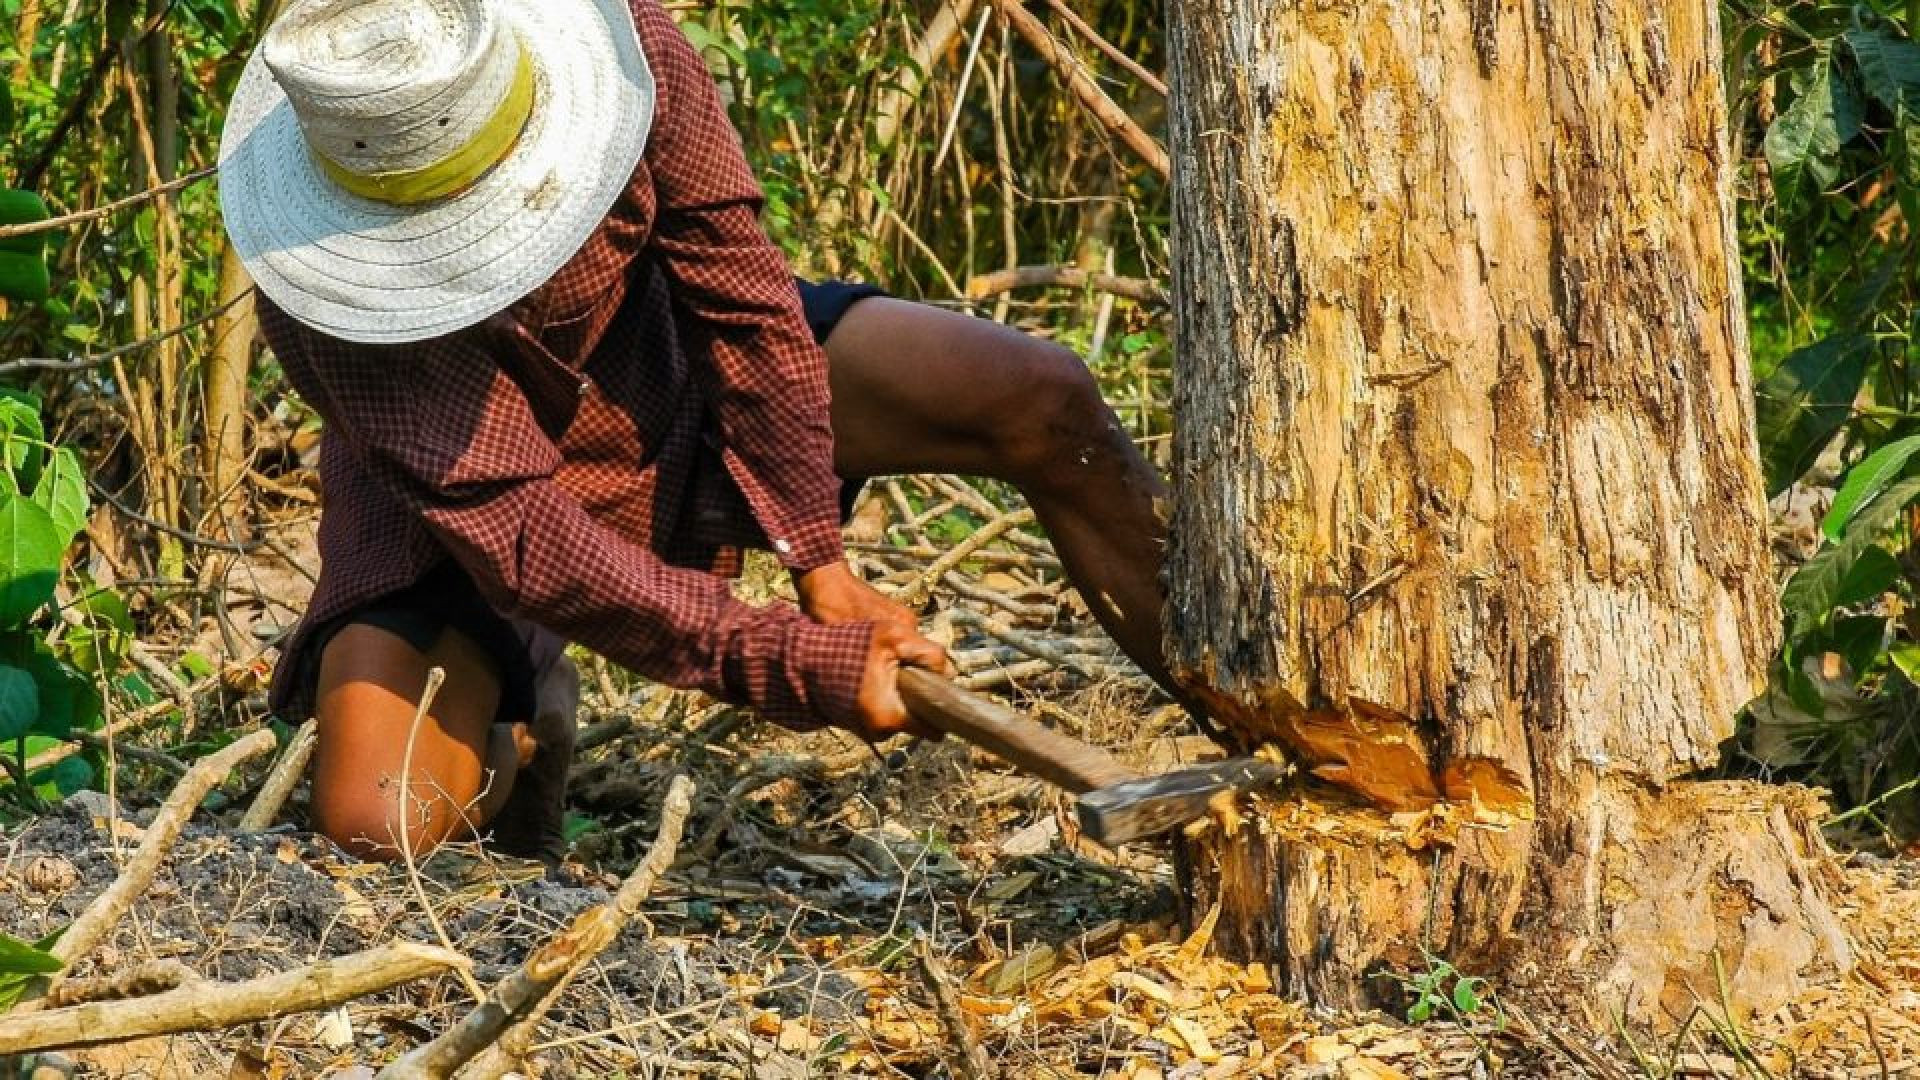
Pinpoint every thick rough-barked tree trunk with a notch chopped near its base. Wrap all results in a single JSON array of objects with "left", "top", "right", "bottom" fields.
[{"left": 1167, "top": 0, "right": 1851, "bottom": 1020}]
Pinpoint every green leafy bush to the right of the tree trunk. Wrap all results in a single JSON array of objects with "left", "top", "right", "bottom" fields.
[{"left": 1726, "top": 0, "right": 1920, "bottom": 832}]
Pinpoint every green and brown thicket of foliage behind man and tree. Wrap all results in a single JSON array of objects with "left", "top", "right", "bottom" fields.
[{"left": 0, "top": 0, "right": 1920, "bottom": 842}]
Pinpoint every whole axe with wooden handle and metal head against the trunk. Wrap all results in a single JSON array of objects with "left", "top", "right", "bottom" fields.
[{"left": 900, "top": 667, "right": 1286, "bottom": 847}]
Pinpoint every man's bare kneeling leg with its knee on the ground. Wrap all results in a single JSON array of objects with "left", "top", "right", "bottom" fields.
[{"left": 313, "top": 625, "right": 578, "bottom": 859}]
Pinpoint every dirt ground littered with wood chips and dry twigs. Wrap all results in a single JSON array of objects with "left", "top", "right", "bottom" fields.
[{"left": 0, "top": 676, "right": 1920, "bottom": 1080}]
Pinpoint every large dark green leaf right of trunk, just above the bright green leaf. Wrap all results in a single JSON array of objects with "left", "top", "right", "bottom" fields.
[{"left": 1755, "top": 331, "right": 1874, "bottom": 496}]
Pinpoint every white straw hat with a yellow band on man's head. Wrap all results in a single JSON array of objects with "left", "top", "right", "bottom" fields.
[{"left": 221, "top": 0, "right": 653, "bottom": 342}]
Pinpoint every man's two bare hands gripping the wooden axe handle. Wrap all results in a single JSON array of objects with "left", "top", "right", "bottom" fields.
[{"left": 793, "top": 563, "right": 952, "bottom": 742}]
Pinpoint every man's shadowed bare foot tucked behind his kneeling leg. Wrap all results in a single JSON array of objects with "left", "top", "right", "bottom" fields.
[{"left": 493, "top": 655, "right": 580, "bottom": 863}]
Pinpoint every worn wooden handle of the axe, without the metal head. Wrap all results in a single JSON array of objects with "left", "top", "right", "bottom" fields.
[{"left": 900, "top": 667, "right": 1140, "bottom": 796}]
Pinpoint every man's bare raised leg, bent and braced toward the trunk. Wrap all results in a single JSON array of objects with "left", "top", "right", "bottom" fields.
[{"left": 828, "top": 298, "right": 1185, "bottom": 700}]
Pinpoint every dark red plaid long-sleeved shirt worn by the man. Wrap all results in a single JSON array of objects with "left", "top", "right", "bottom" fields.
[{"left": 259, "top": 0, "right": 872, "bottom": 726}]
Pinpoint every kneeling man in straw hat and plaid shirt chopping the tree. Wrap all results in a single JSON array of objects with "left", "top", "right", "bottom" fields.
[{"left": 221, "top": 0, "right": 1167, "bottom": 857}]
